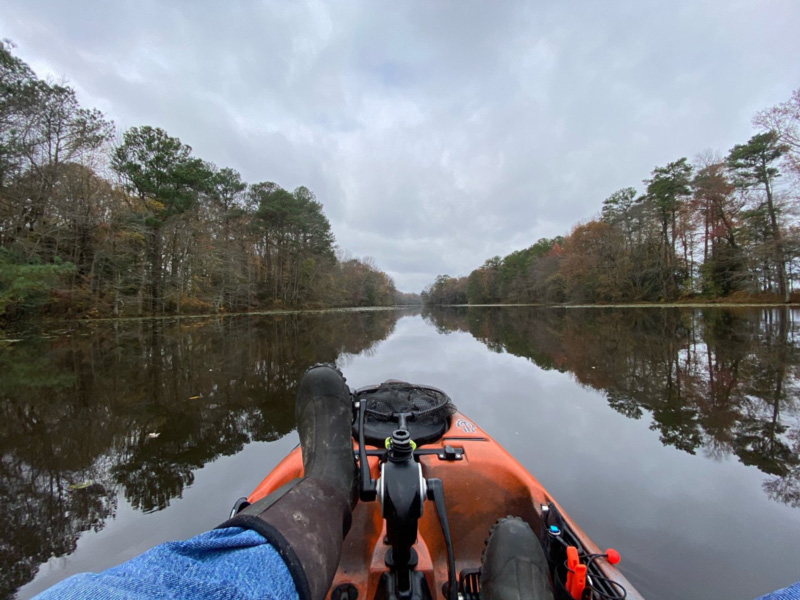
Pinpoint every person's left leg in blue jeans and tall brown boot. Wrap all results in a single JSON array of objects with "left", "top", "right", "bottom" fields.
[{"left": 32, "top": 366, "right": 356, "bottom": 600}]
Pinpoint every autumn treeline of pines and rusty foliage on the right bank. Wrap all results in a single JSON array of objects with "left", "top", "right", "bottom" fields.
[{"left": 423, "top": 89, "right": 800, "bottom": 304}]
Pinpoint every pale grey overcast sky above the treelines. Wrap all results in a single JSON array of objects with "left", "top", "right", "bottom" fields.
[{"left": 0, "top": 0, "right": 800, "bottom": 291}]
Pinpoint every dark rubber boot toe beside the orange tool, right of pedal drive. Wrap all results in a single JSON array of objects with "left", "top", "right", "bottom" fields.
[{"left": 481, "top": 517, "right": 553, "bottom": 600}]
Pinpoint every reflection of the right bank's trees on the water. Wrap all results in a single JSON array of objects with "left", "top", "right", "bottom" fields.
[{"left": 424, "top": 307, "right": 800, "bottom": 508}]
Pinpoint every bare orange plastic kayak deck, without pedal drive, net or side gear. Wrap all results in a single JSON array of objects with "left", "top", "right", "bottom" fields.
[{"left": 248, "top": 412, "right": 640, "bottom": 600}]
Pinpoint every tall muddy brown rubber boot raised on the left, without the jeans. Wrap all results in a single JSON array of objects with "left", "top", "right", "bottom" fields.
[{"left": 220, "top": 365, "right": 358, "bottom": 600}]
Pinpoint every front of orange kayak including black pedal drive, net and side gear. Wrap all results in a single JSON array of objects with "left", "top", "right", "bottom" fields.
[{"left": 239, "top": 382, "right": 641, "bottom": 600}]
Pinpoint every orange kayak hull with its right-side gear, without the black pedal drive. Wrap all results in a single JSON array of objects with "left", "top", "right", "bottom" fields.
[{"left": 248, "top": 397, "right": 641, "bottom": 600}]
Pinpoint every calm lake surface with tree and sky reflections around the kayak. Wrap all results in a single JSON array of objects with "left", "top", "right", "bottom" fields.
[{"left": 0, "top": 308, "right": 800, "bottom": 599}]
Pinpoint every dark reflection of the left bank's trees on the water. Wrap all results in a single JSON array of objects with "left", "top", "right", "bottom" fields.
[{"left": 0, "top": 311, "right": 400, "bottom": 598}]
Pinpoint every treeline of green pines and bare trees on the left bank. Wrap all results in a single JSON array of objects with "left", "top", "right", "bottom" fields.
[{"left": 0, "top": 42, "right": 419, "bottom": 320}]
